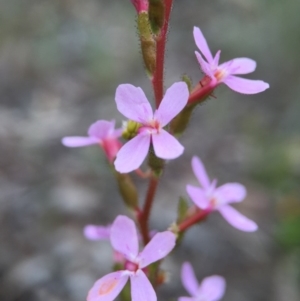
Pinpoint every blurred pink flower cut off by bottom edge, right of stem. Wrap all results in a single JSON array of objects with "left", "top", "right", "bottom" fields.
[{"left": 178, "top": 262, "right": 226, "bottom": 301}]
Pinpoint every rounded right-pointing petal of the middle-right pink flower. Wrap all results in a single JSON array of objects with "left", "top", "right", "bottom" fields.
[{"left": 215, "top": 183, "right": 247, "bottom": 204}]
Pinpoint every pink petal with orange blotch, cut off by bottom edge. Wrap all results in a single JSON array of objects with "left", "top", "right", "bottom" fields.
[{"left": 86, "top": 271, "right": 129, "bottom": 301}]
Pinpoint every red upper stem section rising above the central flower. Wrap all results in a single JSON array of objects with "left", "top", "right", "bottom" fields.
[{"left": 152, "top": 0, "right": 173, "bottom": 108}]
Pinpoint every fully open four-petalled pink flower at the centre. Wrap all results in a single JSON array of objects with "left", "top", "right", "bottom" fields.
[{"left": 115, "top": 82, "right": 189, "bottom": 173}]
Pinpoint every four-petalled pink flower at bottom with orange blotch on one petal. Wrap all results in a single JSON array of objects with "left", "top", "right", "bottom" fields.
[{"left": 87, "top": 215, "right": 176, "bottom": 301}]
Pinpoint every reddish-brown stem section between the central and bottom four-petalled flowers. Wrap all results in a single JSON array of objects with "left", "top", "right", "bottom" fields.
[{"left": 138, "top": 176, "right": 158, "bottom": 245}]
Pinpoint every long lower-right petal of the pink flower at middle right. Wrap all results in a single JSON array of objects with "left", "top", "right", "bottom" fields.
[{"left": 218, "top": 206, "right": 258, "bottom": 232}]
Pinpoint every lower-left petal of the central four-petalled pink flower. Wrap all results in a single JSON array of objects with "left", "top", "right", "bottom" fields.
[{"left": 114, "top": 133, "right": 151, "bottom": 173}]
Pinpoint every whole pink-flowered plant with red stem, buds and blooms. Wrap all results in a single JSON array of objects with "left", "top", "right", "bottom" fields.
[{"left": 62, "top": 0, "right": 269, "bottom": 301}]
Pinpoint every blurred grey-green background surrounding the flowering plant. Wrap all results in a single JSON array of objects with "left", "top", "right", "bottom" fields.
[{"left": 0, "top": 0, "right": 300, "bottom": 301}]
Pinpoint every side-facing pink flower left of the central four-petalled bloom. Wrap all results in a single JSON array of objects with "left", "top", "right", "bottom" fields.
[{"left": 62, "top": 120, "right": 122, "bottom": 162}]
